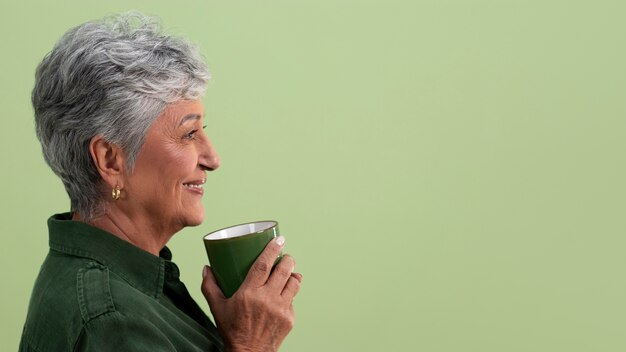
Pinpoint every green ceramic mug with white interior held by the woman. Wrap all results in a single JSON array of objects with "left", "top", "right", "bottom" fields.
[{"left": 204, "top": 220, "right": 283, "bottom": 297}]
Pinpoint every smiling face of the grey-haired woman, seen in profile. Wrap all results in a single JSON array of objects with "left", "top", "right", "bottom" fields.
[{"left": 122, "top": 100, "right": 220, "bottom": 233}]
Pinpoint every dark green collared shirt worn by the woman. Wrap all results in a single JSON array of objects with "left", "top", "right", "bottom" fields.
[{"left": 20, "top": 213, "right": 224, "bottom": 352}]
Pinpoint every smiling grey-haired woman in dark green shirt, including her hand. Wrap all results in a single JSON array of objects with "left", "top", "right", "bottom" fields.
[{"left": 20, "top": 14, "right": 302, "bottom": 352}]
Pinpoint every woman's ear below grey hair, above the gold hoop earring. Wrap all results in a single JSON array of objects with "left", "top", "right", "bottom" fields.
[{"left": 89, "top": 135, "right": 126, "bottom": 188}]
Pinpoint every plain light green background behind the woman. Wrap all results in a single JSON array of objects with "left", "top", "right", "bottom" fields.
[{"left": 0, "top": 0, "right": 626, "bottom": 352}]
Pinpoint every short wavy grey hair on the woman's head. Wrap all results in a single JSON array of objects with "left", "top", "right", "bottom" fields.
[{"left": 32, "top": 12, "right": 210, "bottom": 220}]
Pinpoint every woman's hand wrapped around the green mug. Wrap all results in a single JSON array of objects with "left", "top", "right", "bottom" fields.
[{"left": 202, "top": 236, "right": 302, "bottom": 352}]
